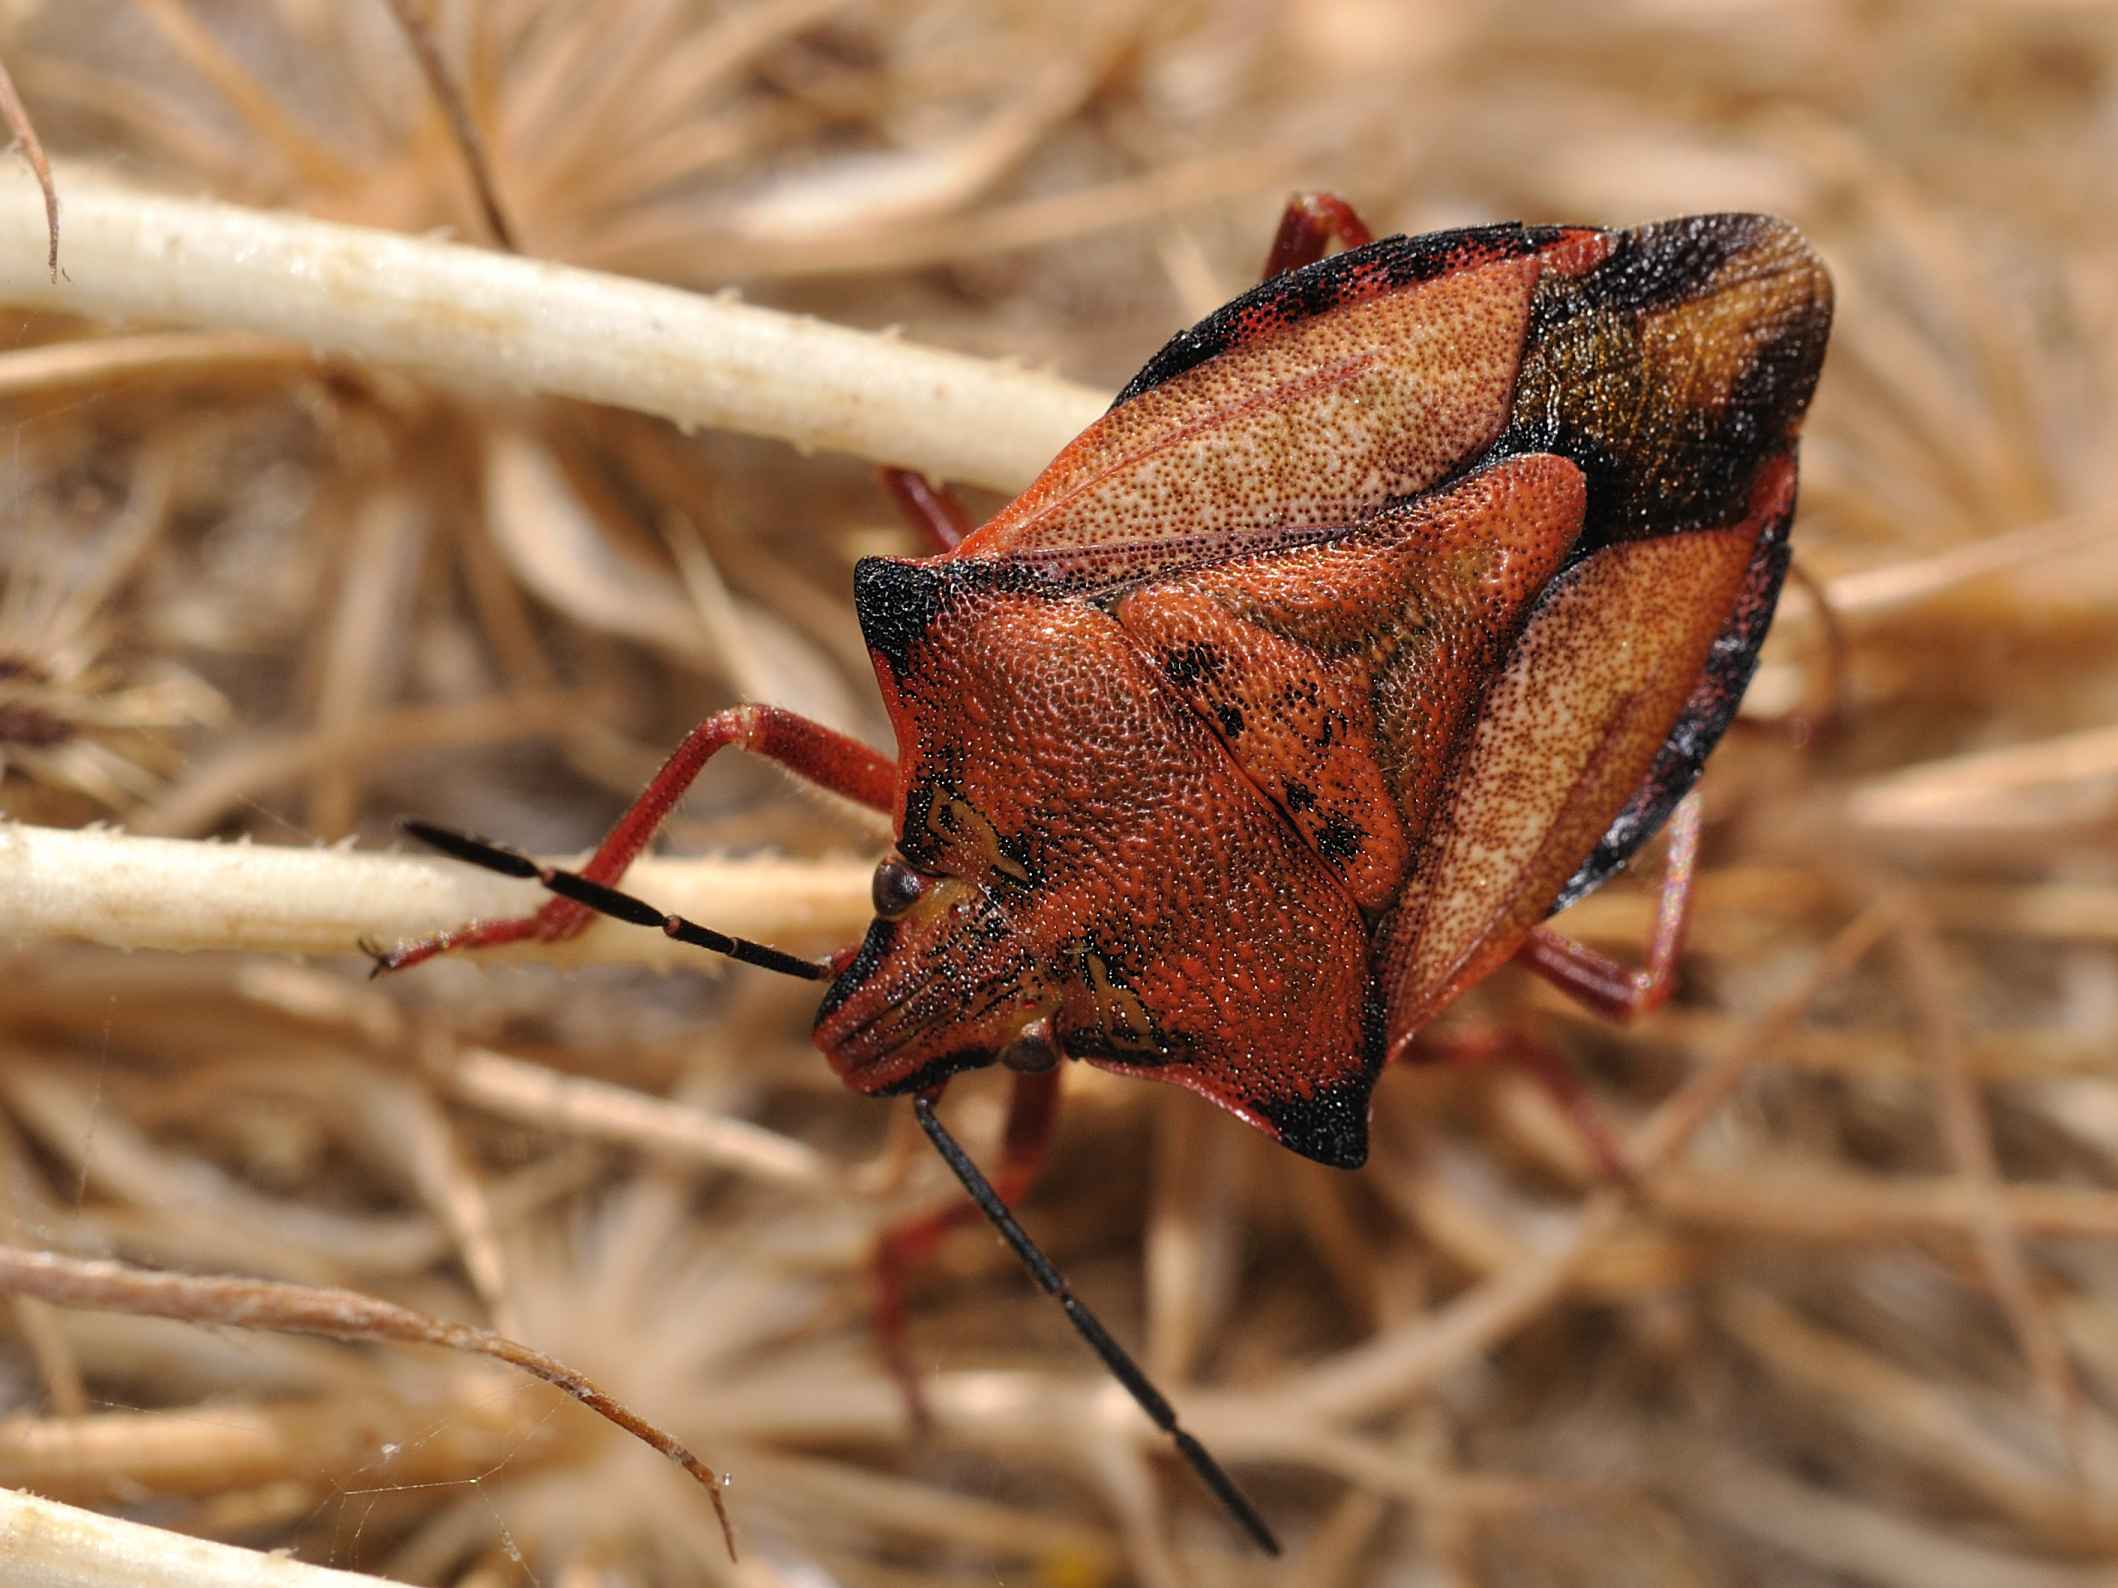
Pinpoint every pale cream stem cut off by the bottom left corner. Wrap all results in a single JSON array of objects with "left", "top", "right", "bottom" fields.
[{"left": 0, "top": 1488, "right": 375, "bottom": 1588}]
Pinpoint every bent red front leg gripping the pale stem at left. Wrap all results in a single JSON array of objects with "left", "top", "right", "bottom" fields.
[{"left": 375, "top": 705, "right": 898, "bottom": 974}]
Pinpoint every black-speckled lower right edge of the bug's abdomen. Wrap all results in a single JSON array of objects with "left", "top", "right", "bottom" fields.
[{"left": 1546, "top": 491, "right": 1794, "bottom": 915}]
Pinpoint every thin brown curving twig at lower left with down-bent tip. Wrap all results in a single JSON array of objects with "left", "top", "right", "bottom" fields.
[{"left": 0, "top": 1247, "right": 735, "bottom": 1560}]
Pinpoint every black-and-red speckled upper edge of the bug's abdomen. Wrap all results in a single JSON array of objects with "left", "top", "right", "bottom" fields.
[{"left": 1110, "top": 220, "right": 1561, "bottom": 409}]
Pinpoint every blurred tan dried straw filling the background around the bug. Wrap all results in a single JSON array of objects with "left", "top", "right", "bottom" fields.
[{"left": 0, "top": 0, "right": 2118, "bottom": 1588}]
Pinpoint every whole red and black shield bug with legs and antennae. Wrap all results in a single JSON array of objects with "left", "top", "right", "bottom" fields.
[{"left": 379, "top": 195, "right": 1832, "bottom": 1550}]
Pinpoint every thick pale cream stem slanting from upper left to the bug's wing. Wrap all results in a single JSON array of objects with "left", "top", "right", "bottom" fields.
[{"left": 0, "top": 174, "right": 1108, "bottom": 491}]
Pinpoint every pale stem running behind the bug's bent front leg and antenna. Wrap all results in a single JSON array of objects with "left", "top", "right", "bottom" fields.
[{"left": 0, "top": 824, "right": 875, "bottom": 968}]
